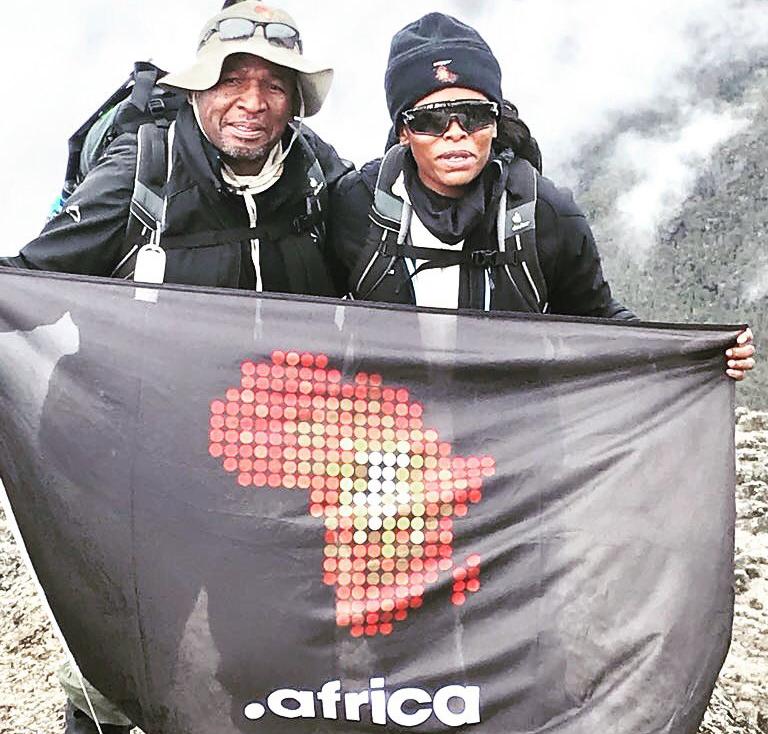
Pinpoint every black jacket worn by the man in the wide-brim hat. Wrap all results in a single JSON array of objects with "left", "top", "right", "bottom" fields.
[{"left": 0, "top": 105, "right": 351, "bottom": 296}]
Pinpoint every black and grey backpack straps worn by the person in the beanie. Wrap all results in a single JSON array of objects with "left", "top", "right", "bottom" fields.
[{"left": 353, "top": 145, "right": 549, "bottom": 313}]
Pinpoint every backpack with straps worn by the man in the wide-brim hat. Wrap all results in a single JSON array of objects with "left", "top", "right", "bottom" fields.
[{"left": 49, "top": 62, "right": 328, "bottom": 283}]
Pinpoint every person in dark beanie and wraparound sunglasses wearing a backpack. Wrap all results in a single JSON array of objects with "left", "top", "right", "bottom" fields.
[{"left": 330, "top": 13, "right": 634, "bottom": 319}]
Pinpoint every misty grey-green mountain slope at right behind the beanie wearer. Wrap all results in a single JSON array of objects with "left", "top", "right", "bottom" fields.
[{"left": 576, "top": 62, "right": 768, "bottom": 409}]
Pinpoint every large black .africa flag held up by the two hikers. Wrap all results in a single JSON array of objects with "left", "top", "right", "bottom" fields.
[{"left": 0, "top": 271, "right": 738, "bottom": 734}]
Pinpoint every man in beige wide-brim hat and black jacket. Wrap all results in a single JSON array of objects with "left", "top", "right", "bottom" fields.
[{"left": 5, "top": 0, "right": 351, "bottom": 296}]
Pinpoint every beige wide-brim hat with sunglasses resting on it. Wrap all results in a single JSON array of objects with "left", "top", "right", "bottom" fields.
[{"left": 160, "top": 0, "right": 333, "bottom": 117}]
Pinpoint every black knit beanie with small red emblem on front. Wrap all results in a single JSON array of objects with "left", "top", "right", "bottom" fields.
[{"left": 384, "top": 13, "right": 503, "bottom": 130}]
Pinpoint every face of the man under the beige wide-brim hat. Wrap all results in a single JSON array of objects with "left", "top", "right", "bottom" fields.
[{"left": 197, "top": 54, "right": 296, "bottom": 175}]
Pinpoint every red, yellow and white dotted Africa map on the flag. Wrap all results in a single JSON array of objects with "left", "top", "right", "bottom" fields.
[{"left": 209, "top": 351, "right": 495, "bottom": 637}]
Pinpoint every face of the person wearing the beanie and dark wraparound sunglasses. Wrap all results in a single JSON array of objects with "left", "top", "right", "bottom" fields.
[{"left": 400, "top": 87, "right": 496, "bottom": 199}]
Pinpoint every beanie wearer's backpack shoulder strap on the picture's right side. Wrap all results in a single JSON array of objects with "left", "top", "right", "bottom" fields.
[{"left": 496, "top": 157, "right": 548, "bottom": 313}]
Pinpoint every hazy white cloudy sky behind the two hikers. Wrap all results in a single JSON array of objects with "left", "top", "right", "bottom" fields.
[{"left": 0, "top": 0, "right": 768, "bottom": 253}]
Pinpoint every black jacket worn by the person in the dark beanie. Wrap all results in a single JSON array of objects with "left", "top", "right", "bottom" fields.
[{"left": 329, "top": 155, "right": 636, "bottom": 320}]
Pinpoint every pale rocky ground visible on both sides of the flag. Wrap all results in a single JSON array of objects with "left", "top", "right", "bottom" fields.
[{"left": 0, "top": 409, "right": 768, "bottom": 734}]
